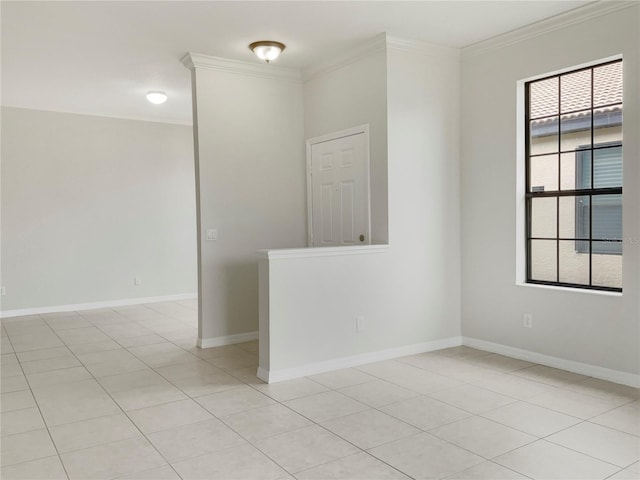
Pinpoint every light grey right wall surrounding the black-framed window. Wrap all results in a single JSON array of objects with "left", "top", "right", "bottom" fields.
[{"left": 461, "top": 5, "right": 640, "bottom": 373}]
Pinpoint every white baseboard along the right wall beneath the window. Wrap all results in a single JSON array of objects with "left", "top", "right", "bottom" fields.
[{"left": 462, "top": 337, "right": 640, "bottom": 388}]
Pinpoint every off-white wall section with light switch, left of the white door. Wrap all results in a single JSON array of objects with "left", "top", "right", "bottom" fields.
[{"left": 185, "top": 56, "right": 306, "bottom": 346}]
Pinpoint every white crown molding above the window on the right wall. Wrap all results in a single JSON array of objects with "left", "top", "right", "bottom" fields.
[{"left": 462, "top": 0, "right": 639, "bottom": 58}]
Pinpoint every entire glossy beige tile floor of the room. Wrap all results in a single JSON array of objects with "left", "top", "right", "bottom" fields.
[{"left": 0, "top": 301, "right": 640, "bottom": 480}]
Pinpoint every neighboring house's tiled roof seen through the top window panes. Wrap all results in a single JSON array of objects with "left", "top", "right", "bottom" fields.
[{"left": 529, "top": 61, "right": 622, "bottom": 120}]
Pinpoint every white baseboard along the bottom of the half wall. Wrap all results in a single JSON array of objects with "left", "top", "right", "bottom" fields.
[{"left": 257, "top": 337, "right": 462, "bottom": 383}]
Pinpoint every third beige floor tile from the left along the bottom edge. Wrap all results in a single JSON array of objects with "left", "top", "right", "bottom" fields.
[{"left": 173, "top": 445, "right": 286, "bottom": 480}]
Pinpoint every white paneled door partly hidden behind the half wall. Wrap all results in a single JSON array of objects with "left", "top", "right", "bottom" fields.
[{"left": 307, "top": 126, "right": 370, "bottom": 247}]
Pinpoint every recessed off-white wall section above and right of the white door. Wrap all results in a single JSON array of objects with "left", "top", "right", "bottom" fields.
[{"left": 304, "top": 36, "right": 389, "bottom": 244}]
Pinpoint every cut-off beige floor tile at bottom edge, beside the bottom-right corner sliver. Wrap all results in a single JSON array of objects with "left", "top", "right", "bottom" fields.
[{"left": 494, "top": 440, "right": 619, "bottom": 480}]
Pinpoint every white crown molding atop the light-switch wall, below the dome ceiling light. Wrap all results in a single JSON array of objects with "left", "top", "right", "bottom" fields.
[{"left": 180, "top": 52, "right": 302, "bottom": 83}]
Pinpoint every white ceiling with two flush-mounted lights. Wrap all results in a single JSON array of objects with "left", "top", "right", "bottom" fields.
[{"left": 1, "top": 0, "right": 591, "bottom": 124}]
